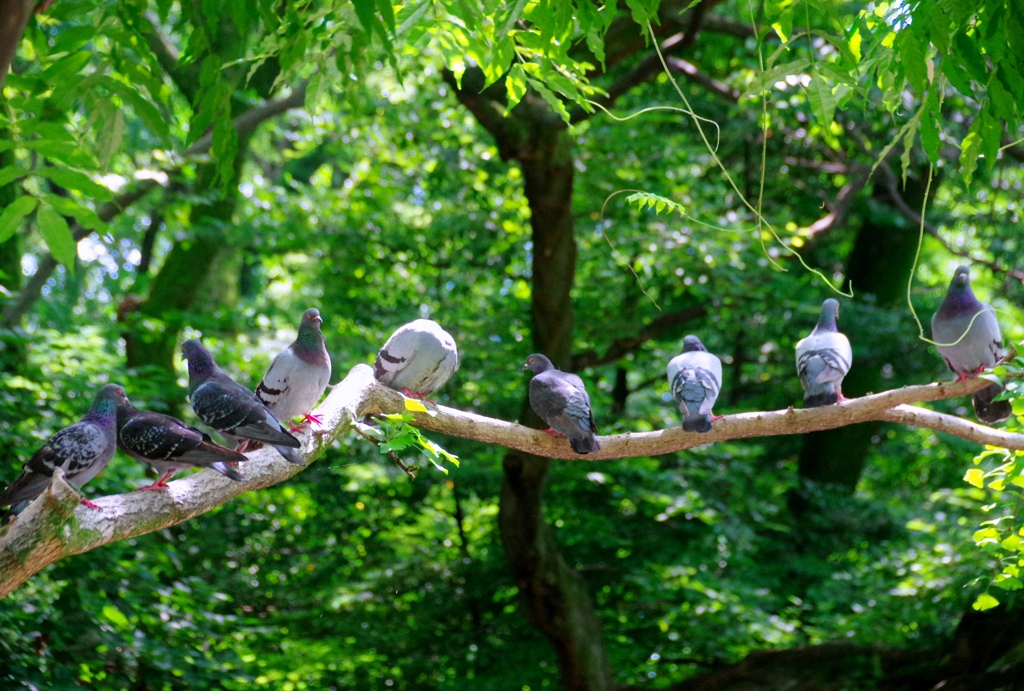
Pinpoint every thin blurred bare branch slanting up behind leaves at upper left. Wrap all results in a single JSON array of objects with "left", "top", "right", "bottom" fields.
[{"left": 0, "top": 84, "right": 306, "bottom": 329}]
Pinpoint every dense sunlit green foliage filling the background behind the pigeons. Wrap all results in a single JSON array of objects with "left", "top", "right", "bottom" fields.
[{"left": 0, "top": 0, "right": 1024, "bottom": 689}]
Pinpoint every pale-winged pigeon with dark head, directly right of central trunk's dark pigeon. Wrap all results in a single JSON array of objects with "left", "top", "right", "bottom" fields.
[{"left": 668, "top": 336, "right": 722, "bottom": 432}]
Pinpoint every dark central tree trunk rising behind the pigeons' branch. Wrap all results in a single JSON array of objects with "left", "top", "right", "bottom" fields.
[{"left": 499, "top": 128, "right": 614, "bottom": 690}]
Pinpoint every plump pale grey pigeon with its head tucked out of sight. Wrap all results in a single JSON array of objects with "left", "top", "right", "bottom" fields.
[{"left": 374, "top": 319, "right": 459, "bottom": 399}]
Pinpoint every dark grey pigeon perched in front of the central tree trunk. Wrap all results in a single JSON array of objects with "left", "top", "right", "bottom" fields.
[{"left": 522, "top": 354, "right": 601, "bottom": 454}]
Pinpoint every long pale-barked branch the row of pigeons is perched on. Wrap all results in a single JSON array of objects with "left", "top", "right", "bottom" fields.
[{"left": 0, "top": 364, "right": 1024, "bottom": 597}]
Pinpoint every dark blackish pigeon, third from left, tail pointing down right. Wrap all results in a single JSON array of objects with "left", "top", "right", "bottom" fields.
[{"left": 181, "top": 339, "right": 306, "bottom": 466}]
